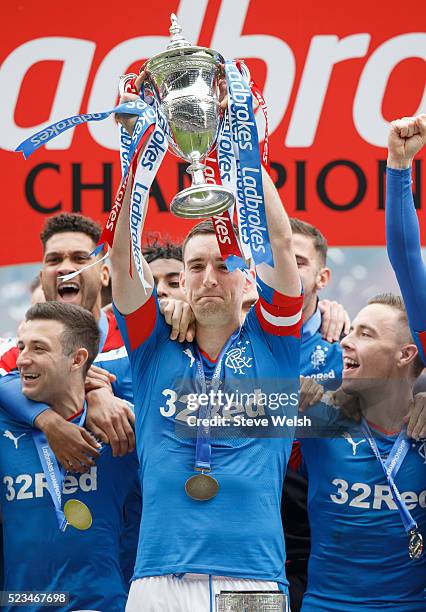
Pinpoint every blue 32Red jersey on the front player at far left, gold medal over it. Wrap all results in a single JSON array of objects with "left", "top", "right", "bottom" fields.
[{"left": 0, "top": 392, "right": 138, "bottom": 612}]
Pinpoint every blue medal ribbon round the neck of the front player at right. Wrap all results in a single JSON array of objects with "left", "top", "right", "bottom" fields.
[{"left": 361, "top": 419, "right": 418, "bottom": 533}]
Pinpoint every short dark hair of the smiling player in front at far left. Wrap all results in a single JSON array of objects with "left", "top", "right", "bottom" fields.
[{"left": 25, "top": 302, "right": 100, "bottom": 375}]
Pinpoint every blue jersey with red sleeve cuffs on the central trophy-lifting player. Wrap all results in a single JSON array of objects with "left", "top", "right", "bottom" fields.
[{"left": 116, "top": 286, "right": 303, "bottom": 585}]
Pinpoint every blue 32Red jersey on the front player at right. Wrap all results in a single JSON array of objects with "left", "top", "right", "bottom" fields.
[{"left": 300, "top": 404, "right": 426, "bottom": 612}]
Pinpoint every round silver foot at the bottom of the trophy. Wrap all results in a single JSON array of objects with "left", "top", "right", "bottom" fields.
[{"left": 170, "top": 184, "right": 235, "bottom": 219}]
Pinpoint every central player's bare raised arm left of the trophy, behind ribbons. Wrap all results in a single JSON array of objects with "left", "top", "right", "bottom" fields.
[{"left": 110, "top": 75, "right": 154, "bottom": 314}]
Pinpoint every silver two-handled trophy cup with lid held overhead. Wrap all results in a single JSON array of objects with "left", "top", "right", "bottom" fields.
[{"left": 126, "top": 14, "right": 235, "bottom": 219}]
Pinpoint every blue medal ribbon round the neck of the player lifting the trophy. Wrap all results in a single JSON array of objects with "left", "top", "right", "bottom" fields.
[{"left": 195, "top": 328, "right": 241, "bottom": 470}]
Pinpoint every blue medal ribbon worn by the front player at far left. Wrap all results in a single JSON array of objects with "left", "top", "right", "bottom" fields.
[{"left": 32, "top": 401, "right": 87, "bottom": 531}]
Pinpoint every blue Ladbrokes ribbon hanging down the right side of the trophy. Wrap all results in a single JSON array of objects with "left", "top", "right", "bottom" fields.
[{"left": 225, "top": 60, "right": 273, "bottom": 266}]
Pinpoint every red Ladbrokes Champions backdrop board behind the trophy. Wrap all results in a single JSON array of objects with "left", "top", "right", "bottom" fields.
[{"left": 0, "top": 0, "right": 426, "bottom": 265}]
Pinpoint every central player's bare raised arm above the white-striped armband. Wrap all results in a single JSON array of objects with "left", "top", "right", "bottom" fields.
[{"left": 256, "top": 169, "right": 302, "bottom": 297}]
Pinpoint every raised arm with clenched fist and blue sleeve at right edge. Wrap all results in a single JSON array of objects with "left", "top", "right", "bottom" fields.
[{"left": 386, "top": 115, "right": 426, "bottom": 332}]
